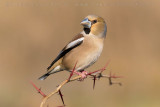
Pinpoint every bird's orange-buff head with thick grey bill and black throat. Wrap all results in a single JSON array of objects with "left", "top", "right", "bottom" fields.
[{"left": 81, "top": 15, "right": 107, "bottom": 37}]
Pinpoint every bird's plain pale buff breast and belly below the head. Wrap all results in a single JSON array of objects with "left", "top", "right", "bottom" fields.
[{"left": 62, "top": 37, "right": 103, "bottom": 71}]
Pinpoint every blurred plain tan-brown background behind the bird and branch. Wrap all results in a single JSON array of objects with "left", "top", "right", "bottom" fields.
[{"left": 0, "top": 0, "right": 160, "bottom": 107}]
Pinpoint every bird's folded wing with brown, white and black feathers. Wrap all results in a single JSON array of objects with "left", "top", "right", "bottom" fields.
[{"left": 47, "top": 34, "right": 84, "bottom": 71}]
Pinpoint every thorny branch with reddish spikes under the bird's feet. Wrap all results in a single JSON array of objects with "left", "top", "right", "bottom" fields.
[{"left": 31, "top": 61, "right": 122, "bottom": 107}]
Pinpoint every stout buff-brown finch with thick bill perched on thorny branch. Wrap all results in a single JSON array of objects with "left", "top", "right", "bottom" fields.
[{"left": 39, "top": 15, "right": 107, "bottom": 80}]
